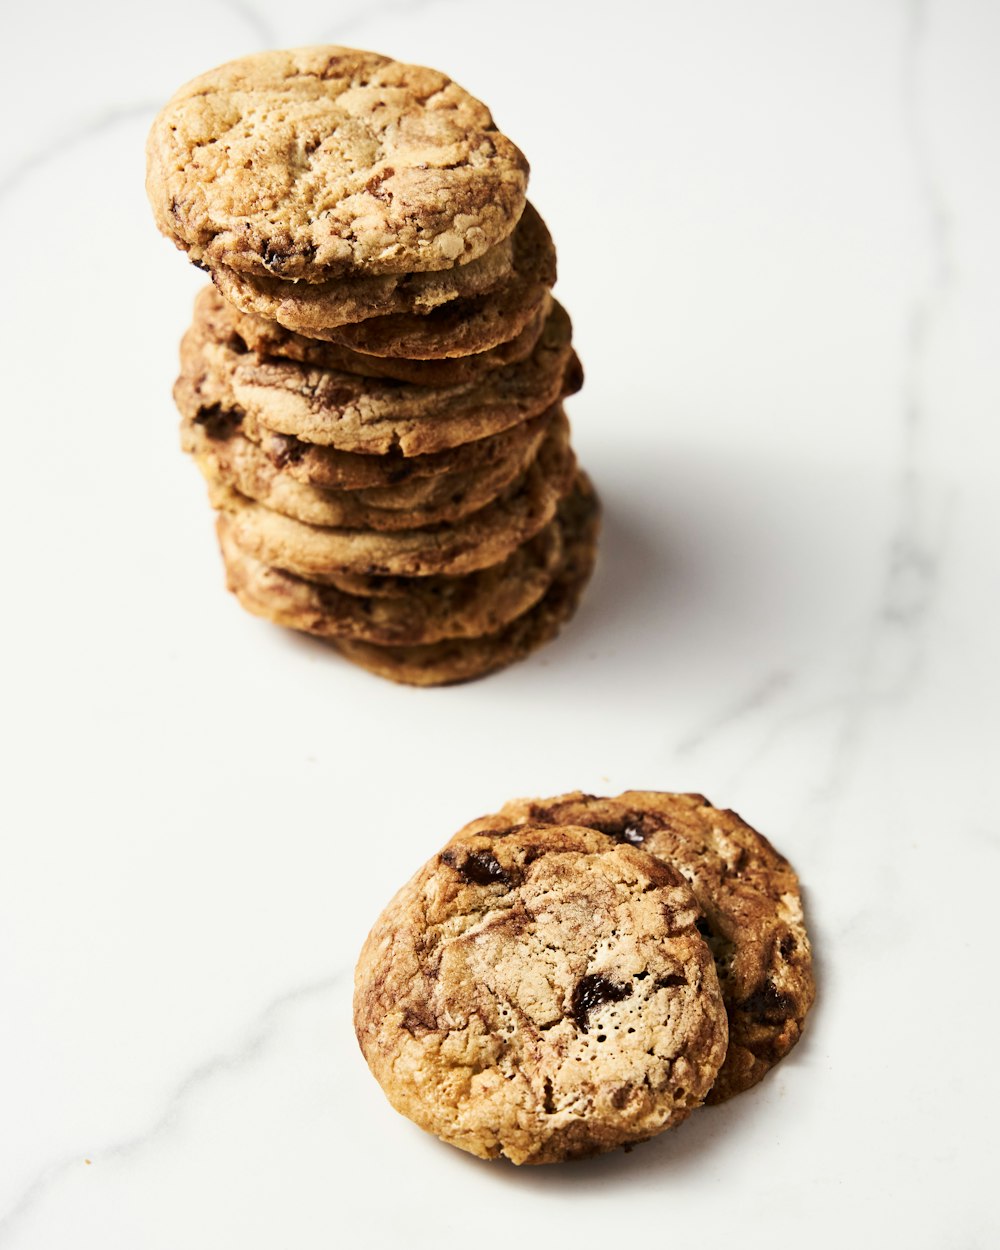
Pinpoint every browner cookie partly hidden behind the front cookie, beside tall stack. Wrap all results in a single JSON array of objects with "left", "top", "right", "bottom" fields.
[{"left": 487, "top": 790, "right": 815, "bottom": 1103}]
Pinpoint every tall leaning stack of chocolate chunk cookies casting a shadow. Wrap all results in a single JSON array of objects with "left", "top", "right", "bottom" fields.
[{"left": 148, "top": 48, "right": 598, "bottom": 685}]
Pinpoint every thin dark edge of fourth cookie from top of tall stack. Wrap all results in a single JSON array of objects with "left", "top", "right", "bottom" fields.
[{"left": 222, "top": 286, "right": 549, "bottom": 386}]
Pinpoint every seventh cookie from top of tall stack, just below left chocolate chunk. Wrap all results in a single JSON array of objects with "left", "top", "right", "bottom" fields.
[{"left": 181, "top": 405, "right": 544, "bottom": 530}]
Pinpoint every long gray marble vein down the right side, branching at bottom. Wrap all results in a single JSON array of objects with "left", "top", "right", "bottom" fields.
[{"left": 676, "top": 0, "right": 958, "bottom": 820}]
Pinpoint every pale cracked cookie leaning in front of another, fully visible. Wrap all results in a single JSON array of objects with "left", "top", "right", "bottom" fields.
[{"left": 354, "top": 825, "right": 726, "bottom": 1164}]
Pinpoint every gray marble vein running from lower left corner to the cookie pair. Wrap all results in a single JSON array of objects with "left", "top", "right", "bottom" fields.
[{"left": 0, "top": 969, "right": 348, "bottom": 1245}]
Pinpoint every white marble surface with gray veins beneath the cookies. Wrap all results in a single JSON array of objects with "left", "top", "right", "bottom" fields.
[{"left": 0, "top": 0, "right": 1000, "bottom": 1250}]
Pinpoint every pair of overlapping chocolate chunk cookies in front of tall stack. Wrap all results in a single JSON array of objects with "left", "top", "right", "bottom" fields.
[{"left": 354, "top": 790, "right": 815, "bottom": 1164}]
